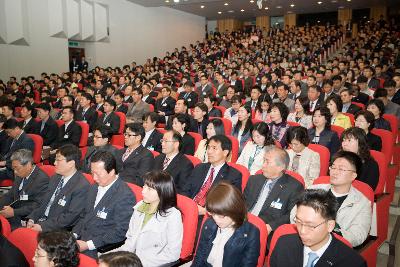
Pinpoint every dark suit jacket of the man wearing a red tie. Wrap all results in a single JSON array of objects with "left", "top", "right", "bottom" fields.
[{"left": 182, "top": 163, "right": 242, "bottom": 199}]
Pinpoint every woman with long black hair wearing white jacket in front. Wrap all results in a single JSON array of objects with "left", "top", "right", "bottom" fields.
[{"left": 113, "top": 171, "right": 183, "bottom": 267}]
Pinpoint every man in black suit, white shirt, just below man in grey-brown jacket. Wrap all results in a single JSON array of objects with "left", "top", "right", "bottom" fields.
[{"left": 142, "top": 112, "right": 162, "bottom": 153}]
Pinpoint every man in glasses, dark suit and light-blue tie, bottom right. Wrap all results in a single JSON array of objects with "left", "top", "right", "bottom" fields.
[{"left": 270, "top": 189, "right": 367, "bottom": 267}]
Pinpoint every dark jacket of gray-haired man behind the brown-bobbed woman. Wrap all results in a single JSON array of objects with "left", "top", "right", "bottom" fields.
[{"left": 244, "top": 174, "right": 304, "bottom": 230}]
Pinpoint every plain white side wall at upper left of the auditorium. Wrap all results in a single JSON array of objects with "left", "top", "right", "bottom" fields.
[{"left": 0, "top": 0, "right": 205, "bottom": 80}]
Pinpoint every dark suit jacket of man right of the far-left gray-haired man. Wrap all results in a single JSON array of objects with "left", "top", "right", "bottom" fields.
[{"left": 28, "top": 171, "right": 90, "bottom": 231}]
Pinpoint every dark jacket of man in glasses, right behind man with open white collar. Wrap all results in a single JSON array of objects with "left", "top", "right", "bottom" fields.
[{"left": 117, "top": 145, "right": 154, "bottom": 186}]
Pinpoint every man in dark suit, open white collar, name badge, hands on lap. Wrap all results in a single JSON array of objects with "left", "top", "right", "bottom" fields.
[{"left": 72, "top": 151, "right": 136, "bottom": 258}]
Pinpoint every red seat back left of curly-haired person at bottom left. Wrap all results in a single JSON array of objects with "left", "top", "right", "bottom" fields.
[{"left": 8, "top": 228, "right": 38, "bottom": 266}]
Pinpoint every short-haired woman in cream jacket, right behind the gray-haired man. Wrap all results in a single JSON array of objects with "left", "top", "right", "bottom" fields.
[{"left": 286, "top": 126, "right": 321, "bottom": 188}]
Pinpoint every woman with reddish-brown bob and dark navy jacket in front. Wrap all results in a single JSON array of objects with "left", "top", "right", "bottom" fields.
[{"left": 192, "top": 182, "right": 260, "bottom": 267}]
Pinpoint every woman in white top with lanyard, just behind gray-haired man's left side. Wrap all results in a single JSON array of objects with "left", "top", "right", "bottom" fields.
[{"left": 236, "top": 122, "right": 275, "bottom": 175}]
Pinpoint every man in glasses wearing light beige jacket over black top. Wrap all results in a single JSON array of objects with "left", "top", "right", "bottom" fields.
[{"left": 291, "top": 151, "right": 372, "bottom": 247}]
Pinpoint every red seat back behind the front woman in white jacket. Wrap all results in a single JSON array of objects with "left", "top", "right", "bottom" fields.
[{"left": 177, "top": 194, "right": 199, "bottom": 260}]
